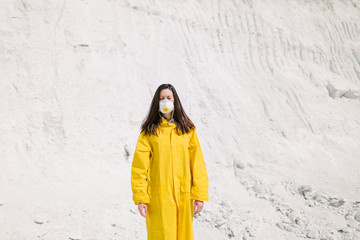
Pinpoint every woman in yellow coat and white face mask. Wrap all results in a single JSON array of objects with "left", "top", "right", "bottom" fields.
[{"left": 131, "top": 84, "right": 209, "bottom": 240}]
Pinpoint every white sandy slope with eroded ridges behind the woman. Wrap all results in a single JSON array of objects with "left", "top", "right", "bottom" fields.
[{"left": 0, "top": 0, "right": 360, "bottom": 240}]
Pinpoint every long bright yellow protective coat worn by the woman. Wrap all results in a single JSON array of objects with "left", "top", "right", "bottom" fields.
[{"left": 131, "top": 119, "right": 209, "bottom": 240}]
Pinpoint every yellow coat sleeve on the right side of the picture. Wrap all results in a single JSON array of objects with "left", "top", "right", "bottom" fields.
[{"left": 189, "top": 129, "right": 209, "bottom": 201}]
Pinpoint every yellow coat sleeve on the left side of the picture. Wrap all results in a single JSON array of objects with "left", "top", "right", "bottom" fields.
[{"left": 131, "top": 132, "right": 153, "bottom": 205}]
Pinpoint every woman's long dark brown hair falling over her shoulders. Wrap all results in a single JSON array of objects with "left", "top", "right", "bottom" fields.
[{"left": 141, "top": 83, "right": 195, "bottom": 136}]
